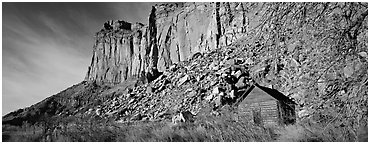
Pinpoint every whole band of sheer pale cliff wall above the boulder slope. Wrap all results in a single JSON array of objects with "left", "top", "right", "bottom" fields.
[{"left": 85, "top": 3, "right": 260, "bottom": 84}]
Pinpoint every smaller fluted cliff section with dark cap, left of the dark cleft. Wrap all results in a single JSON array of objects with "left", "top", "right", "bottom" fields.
[{"left": 85, "top": 21, "right": 147, "bottom": 84}]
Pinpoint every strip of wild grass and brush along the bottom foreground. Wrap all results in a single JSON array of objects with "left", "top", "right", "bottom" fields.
[{"left": 2, "top": 113, "right": 367, "bottom": 142}]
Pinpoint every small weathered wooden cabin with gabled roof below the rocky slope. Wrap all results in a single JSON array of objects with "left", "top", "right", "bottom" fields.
[{"left": 237, "top": 84, "right": 296, "bottom": 125}]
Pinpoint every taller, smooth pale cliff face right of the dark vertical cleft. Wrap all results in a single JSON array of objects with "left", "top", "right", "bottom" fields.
[{"left": 149, "top": 3, "right": 257, "bottom": 71}]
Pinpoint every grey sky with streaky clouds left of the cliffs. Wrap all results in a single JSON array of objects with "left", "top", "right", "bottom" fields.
[{"left": 2, "top": 2, "right": 154, "bottom": 115}]
